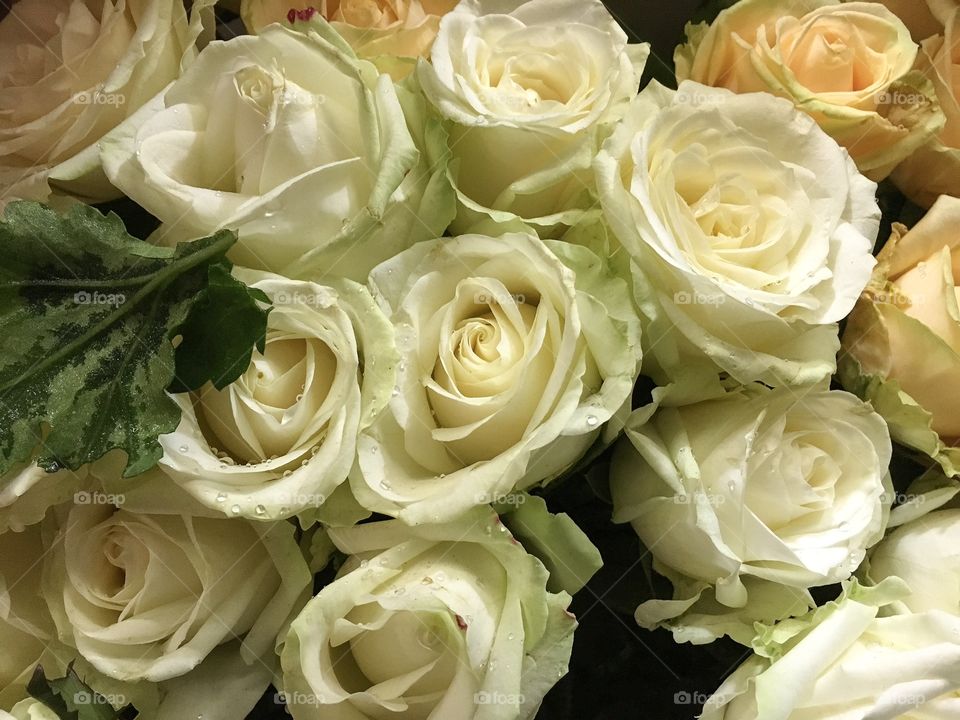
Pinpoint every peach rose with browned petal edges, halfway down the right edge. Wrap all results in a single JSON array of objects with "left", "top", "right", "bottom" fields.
[{"left": 840, "top": 195, "right": 960, "bottom": 474}]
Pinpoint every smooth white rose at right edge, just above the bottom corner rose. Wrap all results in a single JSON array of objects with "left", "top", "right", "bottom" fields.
[{"left": 867, "top": 510, "right": 960, "bottom": 614}]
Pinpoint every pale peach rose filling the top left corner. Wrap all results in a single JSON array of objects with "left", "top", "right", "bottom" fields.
[{"left": 0, "top": 0, "right": 213, "bottom": 206}]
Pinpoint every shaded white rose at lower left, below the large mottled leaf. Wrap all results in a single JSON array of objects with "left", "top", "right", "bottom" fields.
[{"left": 42, "top": 504, "right": 311, "bottom": 682}]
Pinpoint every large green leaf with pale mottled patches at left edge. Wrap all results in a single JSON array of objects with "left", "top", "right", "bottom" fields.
[{"left": 0, "top": 202, "right": 266, "bottom": 477}]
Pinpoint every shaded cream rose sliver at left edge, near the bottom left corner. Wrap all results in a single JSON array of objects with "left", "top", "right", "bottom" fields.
[{"left": 0, "top": 525, "right": 70, "bottom": 708}]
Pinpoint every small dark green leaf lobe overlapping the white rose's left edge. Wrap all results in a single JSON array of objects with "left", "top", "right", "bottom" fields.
[{"left": 169, "top": 265, "right": 270, "bottom": 392}]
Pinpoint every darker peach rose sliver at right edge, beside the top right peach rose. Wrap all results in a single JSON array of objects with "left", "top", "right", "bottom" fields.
[{"left": 892, "top": 9, "right": 960, "bottom": 207}]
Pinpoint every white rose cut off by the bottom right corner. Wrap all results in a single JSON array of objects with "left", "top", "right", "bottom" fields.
[{"left": 700, "top": 583, "right": 960, "bottom": 720}]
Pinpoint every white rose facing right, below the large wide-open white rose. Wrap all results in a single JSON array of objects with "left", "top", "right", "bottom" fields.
[{"left": 610, "top": 385, "right": 891, "bottom": 644}]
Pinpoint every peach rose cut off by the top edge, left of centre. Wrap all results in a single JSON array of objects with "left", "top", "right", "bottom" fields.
[{"left": 240, "top": 0, "right": 458, "bottom": 77}]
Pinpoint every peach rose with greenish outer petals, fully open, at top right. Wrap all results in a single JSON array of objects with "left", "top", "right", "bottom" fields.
[{"left": 675, "top": 0, "right": 944, "bottom": 180}]
